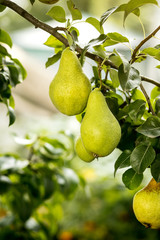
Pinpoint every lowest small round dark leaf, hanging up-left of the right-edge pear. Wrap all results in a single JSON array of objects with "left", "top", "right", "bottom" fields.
[{"left": 122, "top": 168, "right": 143, "bottom": 190}]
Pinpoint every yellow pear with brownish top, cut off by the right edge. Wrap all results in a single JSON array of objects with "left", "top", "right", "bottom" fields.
[{"left": 133, "top": 178, "right": 160, "bottom": 229}]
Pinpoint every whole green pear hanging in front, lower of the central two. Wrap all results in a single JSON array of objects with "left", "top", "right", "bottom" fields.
[{"left": 81, "top": 88, "right": 121, "bottom": 157}]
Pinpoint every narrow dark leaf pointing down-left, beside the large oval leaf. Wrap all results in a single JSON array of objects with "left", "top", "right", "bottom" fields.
[{"left": 114, "top": 150, "right": 131, "bottom": 176}]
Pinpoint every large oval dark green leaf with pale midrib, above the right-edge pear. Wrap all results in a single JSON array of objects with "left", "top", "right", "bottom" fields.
[{"left": 130, "top": 143, "right": 155, "bottom": 173}]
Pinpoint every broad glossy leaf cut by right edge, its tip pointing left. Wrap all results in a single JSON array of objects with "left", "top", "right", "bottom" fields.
[{"left": 136, "top": 116, "right": 160, "bottom": 138}]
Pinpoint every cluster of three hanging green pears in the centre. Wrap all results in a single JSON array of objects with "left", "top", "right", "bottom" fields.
[{"left": 49, "top": 48, "right": 121, "bottom": 162}]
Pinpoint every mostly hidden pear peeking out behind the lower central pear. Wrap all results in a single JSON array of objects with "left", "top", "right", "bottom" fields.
[{"left": 75, "top": 137, "right": 95, "bottom": 162}]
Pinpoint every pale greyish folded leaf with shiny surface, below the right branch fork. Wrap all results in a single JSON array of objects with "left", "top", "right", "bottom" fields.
[{"left": 118, "top": 64, "right": 141, "bottom": 91}]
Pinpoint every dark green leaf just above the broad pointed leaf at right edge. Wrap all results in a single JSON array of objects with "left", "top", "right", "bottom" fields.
[{"left": 128, "top": 99, "right": 146, "bottom": 122}]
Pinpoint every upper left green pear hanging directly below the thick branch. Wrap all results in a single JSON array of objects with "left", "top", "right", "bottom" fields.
[{"left": 49, "top": 48, "right": 91, "bottom": 116}]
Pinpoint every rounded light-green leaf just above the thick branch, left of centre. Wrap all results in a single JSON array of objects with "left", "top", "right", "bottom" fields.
[{"left": 47, "top": 6, "right": 66, "bottom": 22}]
